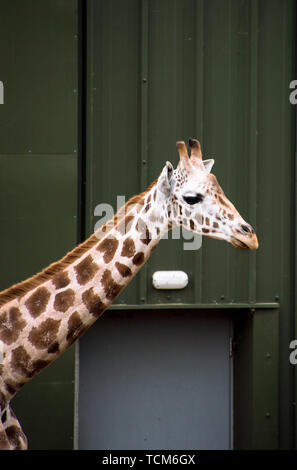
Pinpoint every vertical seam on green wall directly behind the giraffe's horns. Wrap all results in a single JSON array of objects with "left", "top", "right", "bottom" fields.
[{"left": 193, "top": 0, "right": 204, "bottom": 303}]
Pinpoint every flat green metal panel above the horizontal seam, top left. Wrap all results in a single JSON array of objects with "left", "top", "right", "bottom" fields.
[{"left": 0, "top": 0, "right": 77, "bottom": 154}]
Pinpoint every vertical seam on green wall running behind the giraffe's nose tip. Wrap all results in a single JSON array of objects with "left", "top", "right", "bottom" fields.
[{"left": 249, "top": 0, "right": 259, "bottom": 302}]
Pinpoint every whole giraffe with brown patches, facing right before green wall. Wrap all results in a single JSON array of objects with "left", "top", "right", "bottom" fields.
[{"left": 0, "top": 139, "right": 258, "bottom": 449}]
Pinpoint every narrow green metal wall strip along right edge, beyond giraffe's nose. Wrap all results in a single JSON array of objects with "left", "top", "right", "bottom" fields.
[{"left": 256, "top": 1, "right": 296, "bottom": 447}]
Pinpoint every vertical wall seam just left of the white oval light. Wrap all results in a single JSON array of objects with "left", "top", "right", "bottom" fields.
[{"left": 139, "top": 0, "right": 149, "bottom": 304}]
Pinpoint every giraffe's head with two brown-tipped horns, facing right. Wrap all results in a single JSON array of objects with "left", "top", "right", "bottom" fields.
[{"left": 158, "top": 139, "right": 258, "bottom": 250}]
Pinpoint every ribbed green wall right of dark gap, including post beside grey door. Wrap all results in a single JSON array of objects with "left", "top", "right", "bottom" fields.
[{"left": 86, "top": 0, "right": 296, "bottom": 448}]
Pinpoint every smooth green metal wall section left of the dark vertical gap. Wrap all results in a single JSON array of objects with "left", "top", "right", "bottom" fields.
[{"left": 0, "top": 0, "right": 78, "bottom": 449}]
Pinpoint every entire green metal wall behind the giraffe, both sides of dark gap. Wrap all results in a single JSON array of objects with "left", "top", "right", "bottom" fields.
[{"left": 0, "top": 0, "right": 297, "bottom": 449}]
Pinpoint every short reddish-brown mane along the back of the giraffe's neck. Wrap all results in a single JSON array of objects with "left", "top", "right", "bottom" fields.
[{"left": 0, "top": 178, "right": 158, "bottom": 307}]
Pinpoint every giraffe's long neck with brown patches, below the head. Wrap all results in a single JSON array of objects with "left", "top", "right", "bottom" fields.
[{"left": 0, "top": 182, "right": 168, "bottom": 399}]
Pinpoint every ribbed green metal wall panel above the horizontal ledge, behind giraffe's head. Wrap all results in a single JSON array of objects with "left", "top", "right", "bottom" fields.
[{"left": 87, "top": 0, "right": 293, "bottom": 304}]
